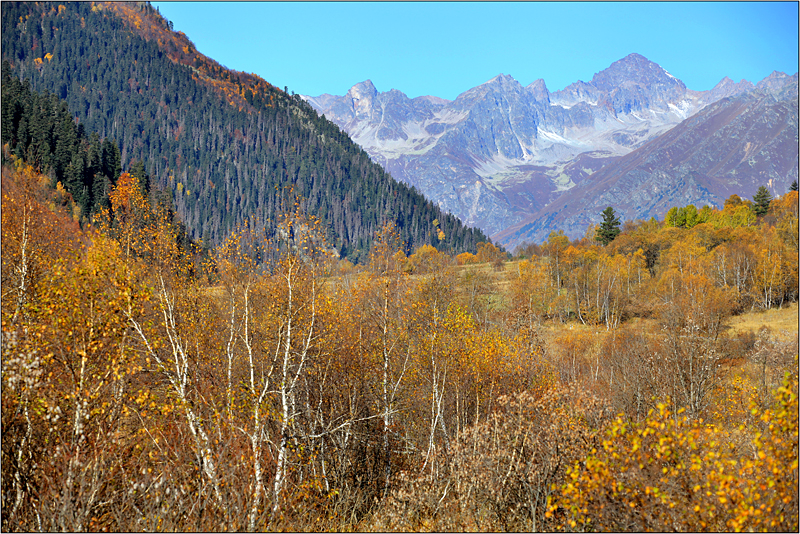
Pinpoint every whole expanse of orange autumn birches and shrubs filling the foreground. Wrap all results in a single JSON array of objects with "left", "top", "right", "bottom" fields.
[{"left": 2, "top": 158, "right": 797, "bottom": 530}]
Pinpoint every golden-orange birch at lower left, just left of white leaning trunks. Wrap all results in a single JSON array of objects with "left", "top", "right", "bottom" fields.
[{"left": 3, "top": 207, "right": 148, "bottom": 530}]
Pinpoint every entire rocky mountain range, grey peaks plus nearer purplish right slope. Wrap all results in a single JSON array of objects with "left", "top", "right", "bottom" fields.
[{"left": 302, "top": 54, "right": 798, "bottom": 247}]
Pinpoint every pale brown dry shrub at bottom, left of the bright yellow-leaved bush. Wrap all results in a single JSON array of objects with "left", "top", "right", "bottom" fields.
[{"left": 365, "top": 387, "right": 603, "bottom": 531}]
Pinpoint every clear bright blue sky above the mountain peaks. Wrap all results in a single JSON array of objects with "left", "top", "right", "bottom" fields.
[{"left": 153, "top": 2, "right": 798, "bottom": 100}]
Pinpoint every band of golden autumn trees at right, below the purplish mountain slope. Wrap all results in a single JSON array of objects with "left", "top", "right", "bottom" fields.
[{"left": 517, "top": 191, "right": 798, "bottom": 328}]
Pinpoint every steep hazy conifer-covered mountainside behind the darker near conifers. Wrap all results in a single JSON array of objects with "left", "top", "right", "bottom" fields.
[{"left": 2, "top": 2, "right": 487, "bottom": 261}]
